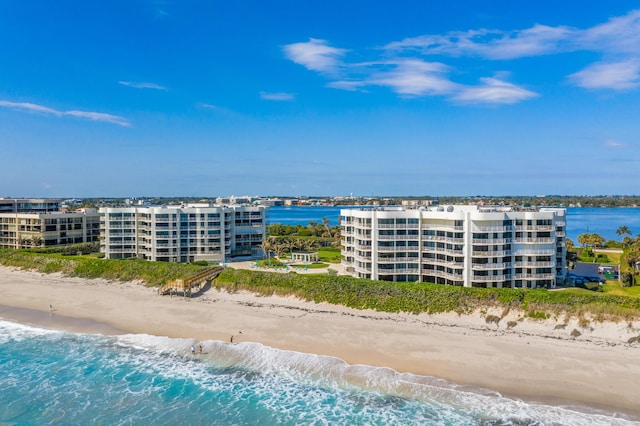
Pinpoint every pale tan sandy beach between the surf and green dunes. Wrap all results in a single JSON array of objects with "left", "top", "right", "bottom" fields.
[{"left": 0, "top": 267, "right": 640, "bottom": 416}]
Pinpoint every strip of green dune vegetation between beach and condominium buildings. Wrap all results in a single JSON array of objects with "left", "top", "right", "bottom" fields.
[{"left": 0, "top": 250, "right": 640, "bottom": 321}]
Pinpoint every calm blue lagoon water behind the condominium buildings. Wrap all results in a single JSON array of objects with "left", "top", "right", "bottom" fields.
[{"left": 269, "top": 206, "right": 640, "bottom": 242}]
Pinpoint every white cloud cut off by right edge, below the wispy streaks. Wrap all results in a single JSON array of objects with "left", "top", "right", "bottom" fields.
[{"left": 569, "top": 59, "right": 640, "bottom": 90}]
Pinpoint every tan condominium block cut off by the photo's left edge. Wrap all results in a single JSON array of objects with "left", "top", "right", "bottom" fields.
[{"left": 0, "top": 198, "right": 100, "bottom": 249}]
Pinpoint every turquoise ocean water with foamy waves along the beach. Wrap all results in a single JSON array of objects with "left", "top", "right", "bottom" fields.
[{"left": 0, "top": 320, "right": 638, "bottom": 426}]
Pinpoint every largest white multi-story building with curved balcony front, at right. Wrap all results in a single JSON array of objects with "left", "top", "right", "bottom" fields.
[{"left": 340, "top": 206, "right": 566, "bottom": 288}]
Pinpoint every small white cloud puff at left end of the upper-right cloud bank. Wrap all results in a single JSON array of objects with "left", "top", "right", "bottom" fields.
[{"left": 282, "top": 38, "right": 347, "bottom": 73}]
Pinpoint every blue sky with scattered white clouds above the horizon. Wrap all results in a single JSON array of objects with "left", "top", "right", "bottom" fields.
[{"left": 0, "top": 0, "right": 640, "bottom": 197}]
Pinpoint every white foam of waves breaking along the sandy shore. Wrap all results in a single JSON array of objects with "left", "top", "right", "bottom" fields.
[{"left": 112, "top": 335, "right": 637, "bottom": 425}]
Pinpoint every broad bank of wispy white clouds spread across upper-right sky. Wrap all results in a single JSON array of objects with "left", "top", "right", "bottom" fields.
[{"left": 283, "top": 10, "right": 640, "bottom": 104}]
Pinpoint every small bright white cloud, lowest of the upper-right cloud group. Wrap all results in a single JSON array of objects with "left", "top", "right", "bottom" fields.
[{"left": 452, "top": 78, "right": 538, "bottom": 104}]
